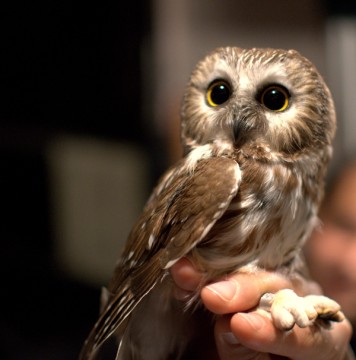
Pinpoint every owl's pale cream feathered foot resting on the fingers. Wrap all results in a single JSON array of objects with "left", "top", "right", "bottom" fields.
[{"left": 259, "top": 289, "right": 345, "bottom": 331}]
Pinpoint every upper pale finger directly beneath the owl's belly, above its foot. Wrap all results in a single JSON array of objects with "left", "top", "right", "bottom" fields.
[{"left": 201, "top": 271, "right": 293, "bottom": 314}]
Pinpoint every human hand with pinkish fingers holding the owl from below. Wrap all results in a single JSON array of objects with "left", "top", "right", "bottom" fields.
[{"left": 171, "top": 258, "right": 354, "bottom": 360}]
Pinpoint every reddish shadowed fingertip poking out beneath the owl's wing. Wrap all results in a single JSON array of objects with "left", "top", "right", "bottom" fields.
[{"left": 171, "top": 257, "right": 202, "bottom": 292}]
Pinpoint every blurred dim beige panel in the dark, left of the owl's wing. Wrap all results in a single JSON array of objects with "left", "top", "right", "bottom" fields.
[{"left": 47, "top": 136, "right": 150, "bottom": 288}]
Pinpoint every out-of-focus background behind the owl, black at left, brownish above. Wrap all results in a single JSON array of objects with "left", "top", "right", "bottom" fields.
[{"left": 0, "top": 0, "right": 356, "bottom": 360}]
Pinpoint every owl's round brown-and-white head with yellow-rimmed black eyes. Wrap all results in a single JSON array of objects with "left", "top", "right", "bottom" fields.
[{"left": 182, "top": 47, "right": 335, "bottom": 154}]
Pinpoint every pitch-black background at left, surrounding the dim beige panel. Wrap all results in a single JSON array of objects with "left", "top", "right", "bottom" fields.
[{"left": 0, "top": 0, "right": 151, "bottom": 360}]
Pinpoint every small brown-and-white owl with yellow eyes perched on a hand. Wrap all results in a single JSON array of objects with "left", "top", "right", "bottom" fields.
[{"left": 81, "top": 47, "right": 342, "bottom": 360}]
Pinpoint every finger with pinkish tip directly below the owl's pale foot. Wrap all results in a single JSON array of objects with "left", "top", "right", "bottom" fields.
[{"left": 230, "top": 312, "right": 352, "bottom": 360}]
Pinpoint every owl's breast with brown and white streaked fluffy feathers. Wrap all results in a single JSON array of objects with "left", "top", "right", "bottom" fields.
[{"left": 193, "top": 157, "right": 317, "bottom": 272}]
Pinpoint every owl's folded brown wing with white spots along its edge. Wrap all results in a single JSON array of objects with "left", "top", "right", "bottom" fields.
[{"left": 81, "top": 157, "right": 241, "bottom": 359}]
